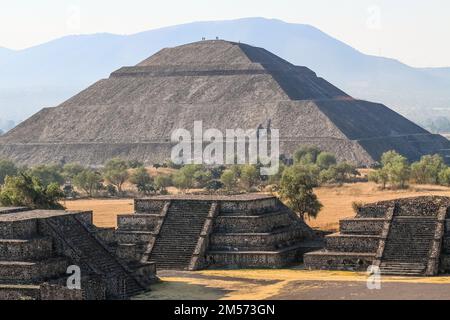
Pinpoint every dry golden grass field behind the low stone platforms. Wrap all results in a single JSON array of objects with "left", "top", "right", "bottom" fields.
[{"left": 65, "top": 182, "right": 450, "bottom": 231}]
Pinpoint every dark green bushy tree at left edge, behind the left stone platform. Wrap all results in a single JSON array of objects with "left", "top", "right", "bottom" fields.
[{"left": 0, "top": 173, "right": 64, "bottom": 209}]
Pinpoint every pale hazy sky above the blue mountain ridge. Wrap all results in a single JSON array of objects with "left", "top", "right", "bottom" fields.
[{"left": 0, "top": 0, "right": 450, "bottom": 66}]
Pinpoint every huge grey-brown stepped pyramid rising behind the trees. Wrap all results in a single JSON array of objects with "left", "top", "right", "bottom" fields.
[{"left": 0, "top": 41, "right": 450, "bottom": 165}]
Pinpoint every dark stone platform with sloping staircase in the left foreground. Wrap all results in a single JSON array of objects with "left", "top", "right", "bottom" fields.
[{"left": 0, "top": 208, "right": 156, "bottom": 300}]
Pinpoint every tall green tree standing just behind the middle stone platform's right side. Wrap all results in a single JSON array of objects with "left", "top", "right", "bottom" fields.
[{"left": 280, "top": 165, "right": 323, "bottom": 220}]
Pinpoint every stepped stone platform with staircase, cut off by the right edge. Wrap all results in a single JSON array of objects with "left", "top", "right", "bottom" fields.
[{"left": 304, "top": 197, "right": 450, "bottom": 276}]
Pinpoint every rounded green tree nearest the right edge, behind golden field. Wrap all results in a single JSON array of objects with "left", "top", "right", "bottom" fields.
[{"left": 411, "top": 154, "right": 446, "bottom": 184}]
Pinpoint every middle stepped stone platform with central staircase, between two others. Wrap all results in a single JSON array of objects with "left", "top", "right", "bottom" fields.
[{"left": 116, "top": 195, "right": 321, "bottom": 270}]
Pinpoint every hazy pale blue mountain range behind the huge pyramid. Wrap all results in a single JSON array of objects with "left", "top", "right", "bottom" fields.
[{"left": 0, "top": 18, "right": 450, "bottom": 125}]
